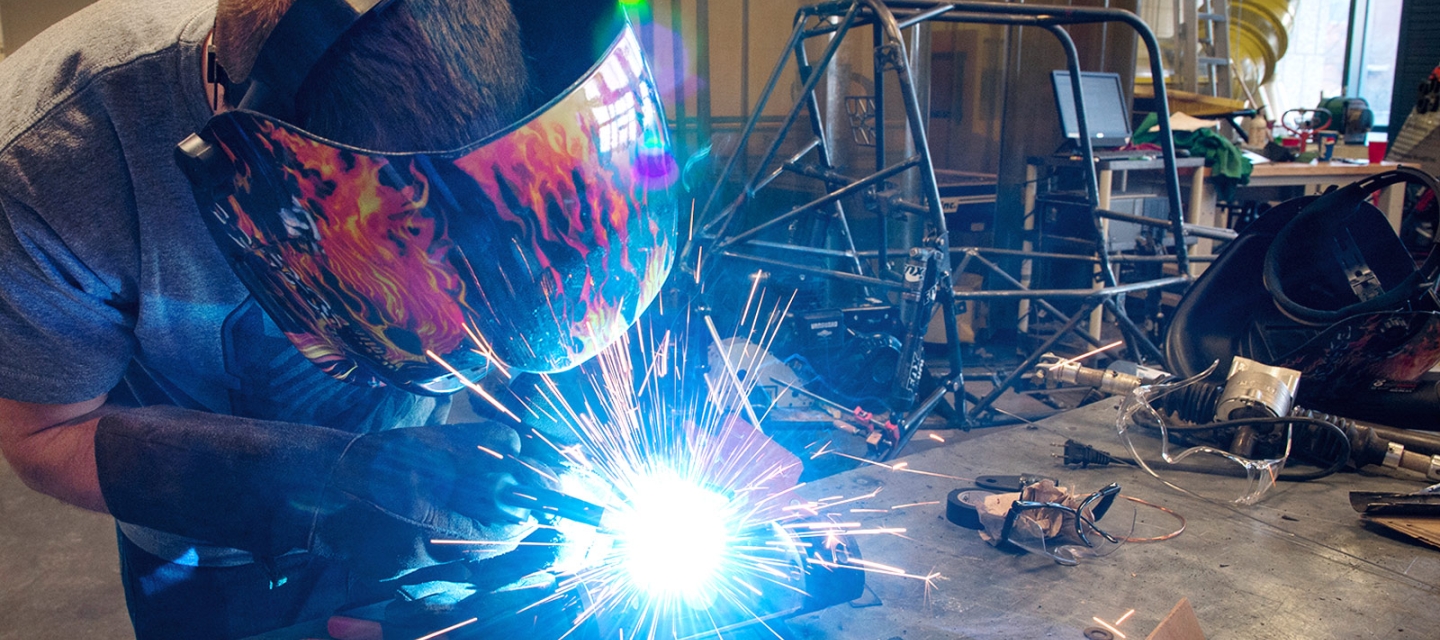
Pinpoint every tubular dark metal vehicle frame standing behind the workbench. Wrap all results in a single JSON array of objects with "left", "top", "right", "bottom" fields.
[{"left": 683, "top": 0, "right": 1189, "bottom": 458}]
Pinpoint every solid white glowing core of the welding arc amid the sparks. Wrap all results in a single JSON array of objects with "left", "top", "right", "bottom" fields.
[{"left": 605, "top": 473, "right": 734, "bottom": 605}]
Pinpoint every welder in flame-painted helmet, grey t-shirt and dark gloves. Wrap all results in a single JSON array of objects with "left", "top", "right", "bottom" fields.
[{"left": 0, "top": 0, "right": 675, "bottom": 639}]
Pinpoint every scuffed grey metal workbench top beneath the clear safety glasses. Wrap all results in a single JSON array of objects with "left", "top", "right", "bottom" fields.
[{"left": 791, "top": 401, "right": 1440, "bottom": 640}]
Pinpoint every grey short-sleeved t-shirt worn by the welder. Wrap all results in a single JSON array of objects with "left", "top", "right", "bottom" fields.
[{"left": 0, "top": 0, "right": 448, "bottom": 559}]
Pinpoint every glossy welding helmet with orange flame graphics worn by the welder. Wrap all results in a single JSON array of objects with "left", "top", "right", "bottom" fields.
[{"left": 177, "top": 0, "right": 677, "bottom": 394}]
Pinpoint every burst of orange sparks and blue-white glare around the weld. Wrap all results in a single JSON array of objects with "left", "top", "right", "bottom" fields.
[{"left": 429, "top": 286, "right": 949, "bottom": 639}]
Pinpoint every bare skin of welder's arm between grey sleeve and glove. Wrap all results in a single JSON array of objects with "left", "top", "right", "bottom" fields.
[{"left": 0, "top": 395, "right": 108, "bottom": 513}]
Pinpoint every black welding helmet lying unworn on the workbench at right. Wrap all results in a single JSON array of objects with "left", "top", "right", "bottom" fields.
[{"left": 1165, "top": 167, "right": 1440, "bottom": 419}]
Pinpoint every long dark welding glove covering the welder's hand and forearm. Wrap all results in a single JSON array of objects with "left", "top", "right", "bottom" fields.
[{"left": 95, "top": 406, "right": 539, "bottom": 579}]
